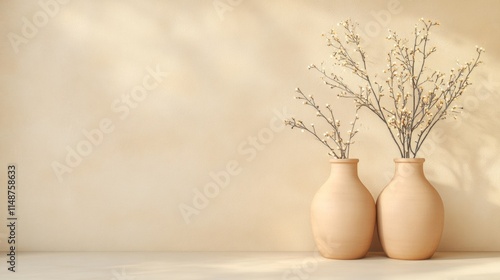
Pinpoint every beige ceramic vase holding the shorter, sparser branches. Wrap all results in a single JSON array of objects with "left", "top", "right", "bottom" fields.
[{"left": 311, "top": 159, "right": 376, "bottom": 259}]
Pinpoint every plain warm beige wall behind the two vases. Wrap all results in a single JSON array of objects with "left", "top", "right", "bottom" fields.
[{"left": 0, "top": 0, "right": 500, "bottom": 251}]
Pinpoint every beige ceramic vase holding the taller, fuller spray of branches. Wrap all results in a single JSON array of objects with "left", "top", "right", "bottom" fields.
[{"left": 377, "top": 158, "right": 444, "bottom": 260}]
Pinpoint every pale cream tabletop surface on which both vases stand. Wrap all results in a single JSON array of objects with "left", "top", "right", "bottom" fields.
[{"left": 0, "top": 252, "right": 500, "bottom": 280}]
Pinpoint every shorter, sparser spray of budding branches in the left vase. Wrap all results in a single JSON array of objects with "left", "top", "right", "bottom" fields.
[{"left": 285, "top": 88, "right": 359, "bottom": 159}]
